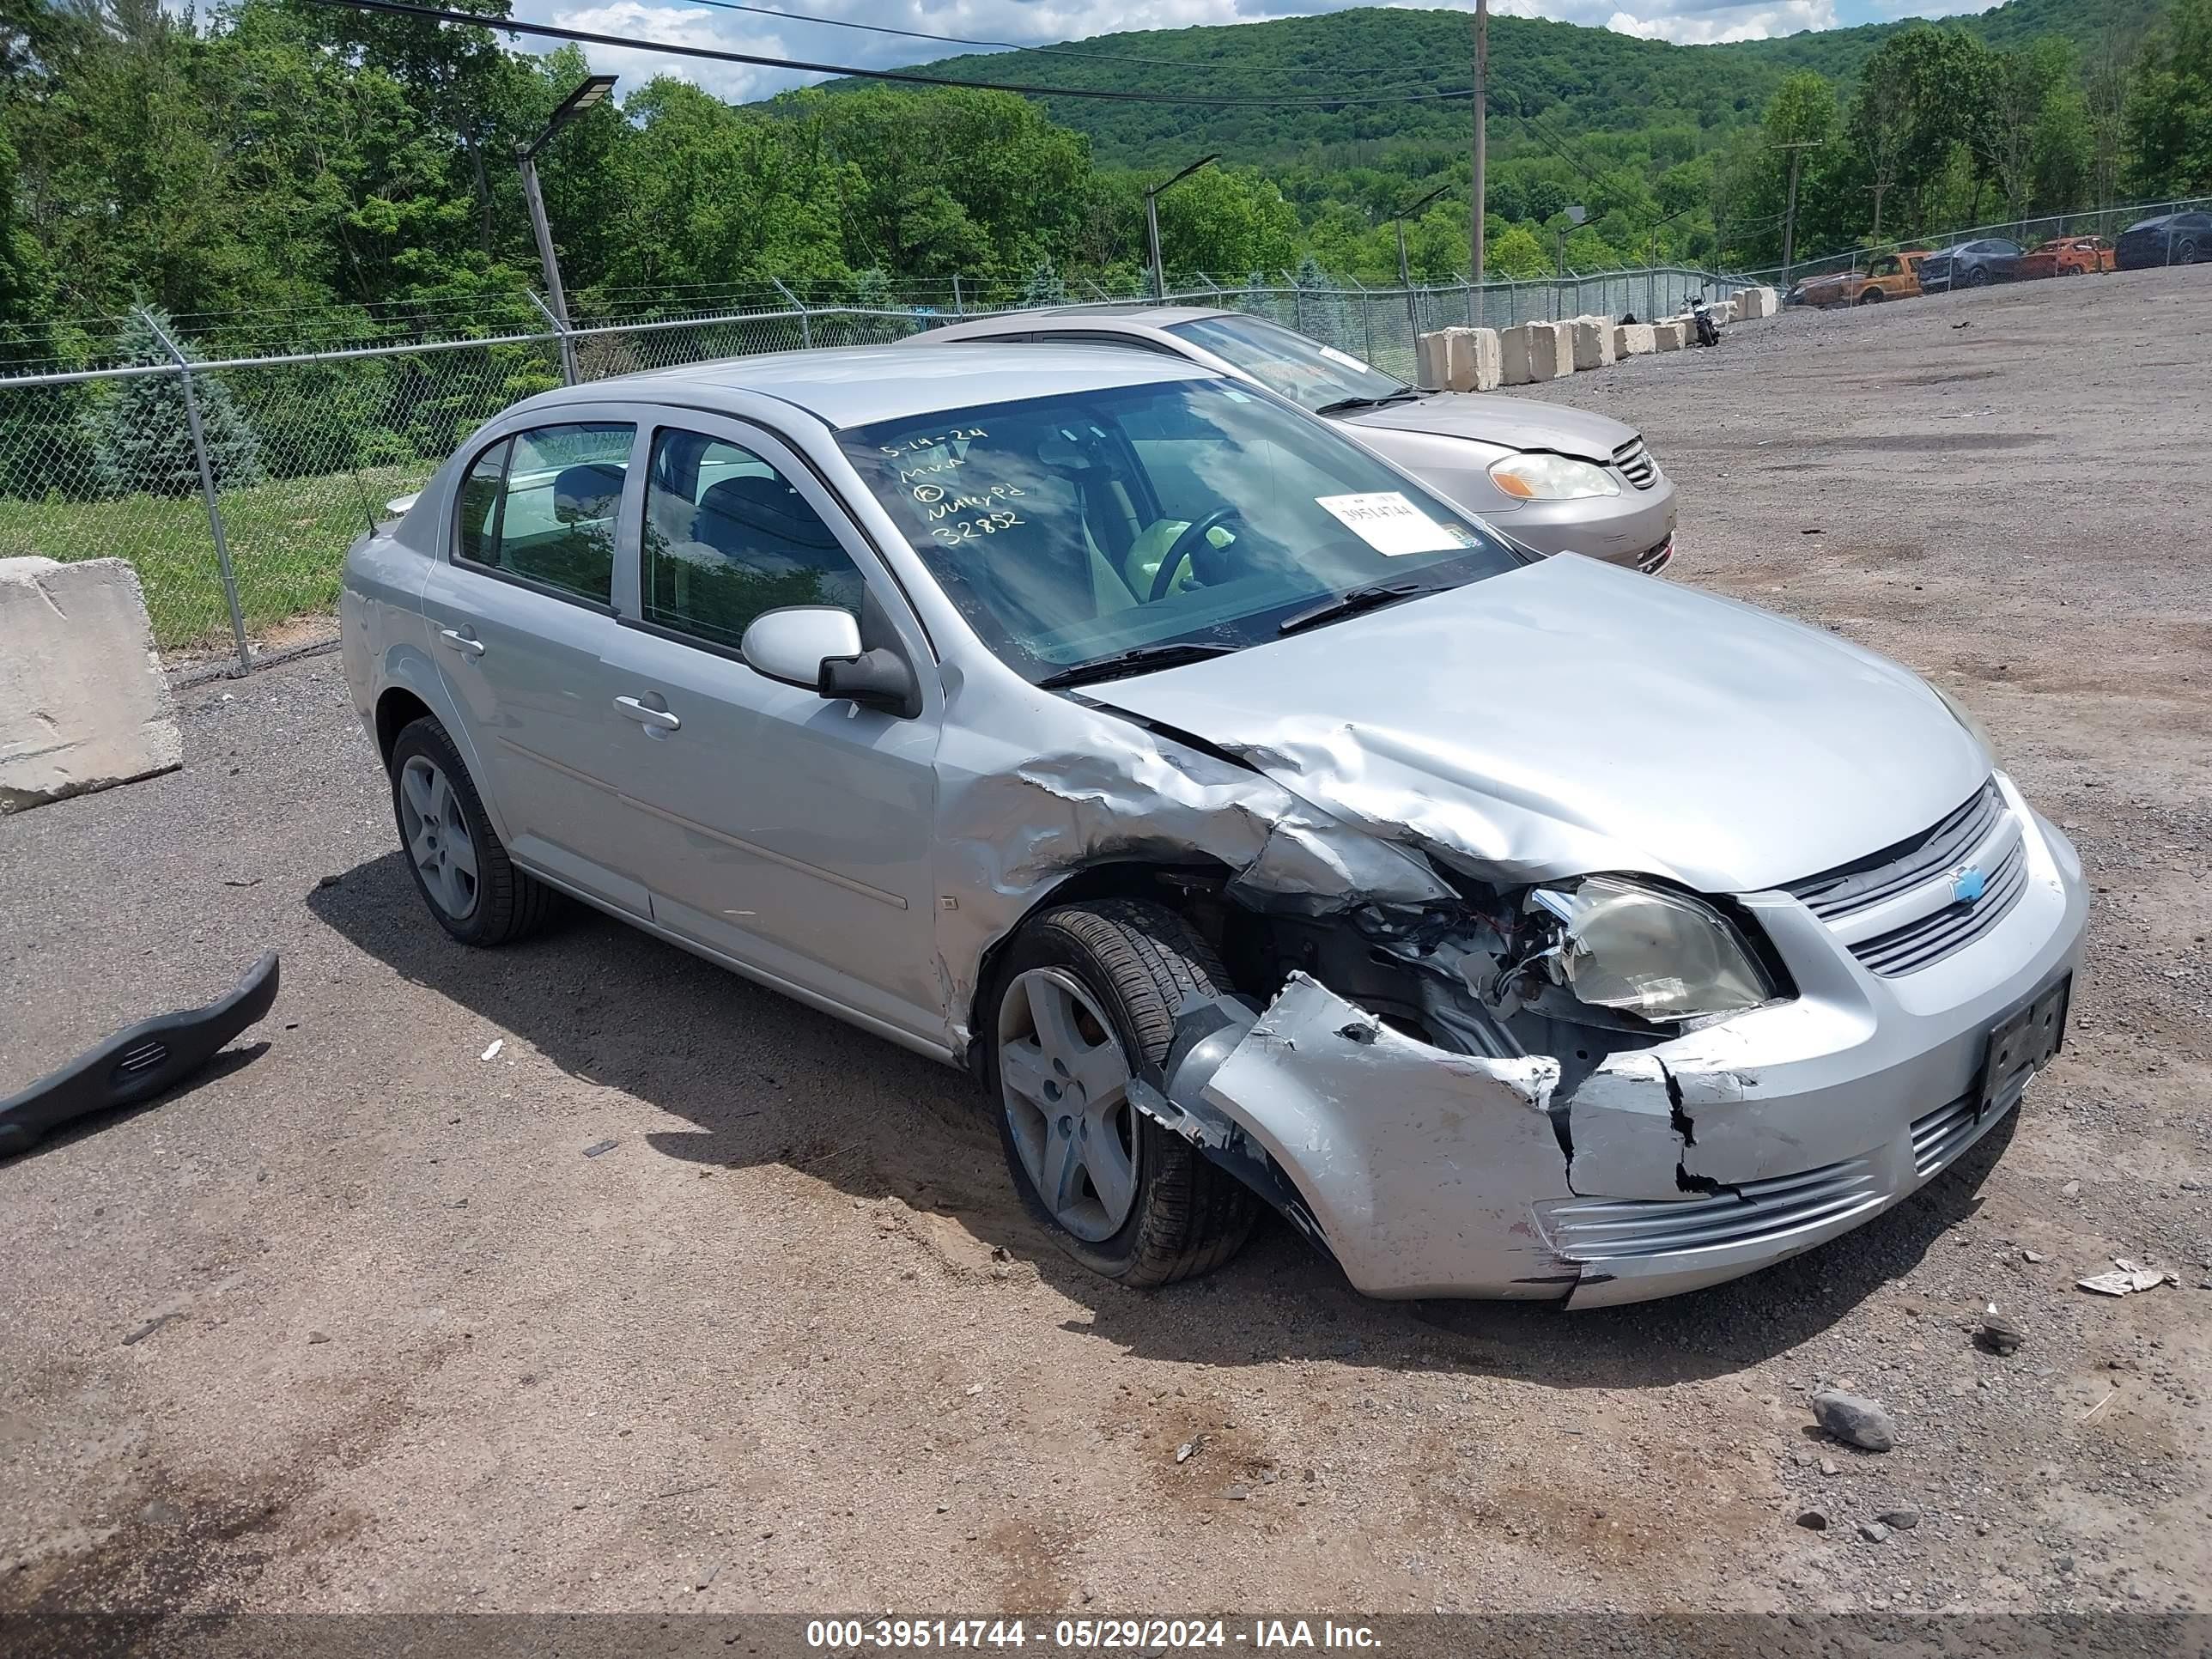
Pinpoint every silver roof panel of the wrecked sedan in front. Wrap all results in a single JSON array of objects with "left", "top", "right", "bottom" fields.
[{"left": 513, "top": 345, "right": 1217, "bottom": 427}]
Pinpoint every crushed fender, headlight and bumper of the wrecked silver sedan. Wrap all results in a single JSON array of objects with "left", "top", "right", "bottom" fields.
[{"left": 940, "top": 677, "right": 2086, "bottom": 1307}]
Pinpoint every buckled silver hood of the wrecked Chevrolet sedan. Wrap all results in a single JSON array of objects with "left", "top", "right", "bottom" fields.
[{"left": 1093, "top": 556, "right": 1990, "bottom": 894}]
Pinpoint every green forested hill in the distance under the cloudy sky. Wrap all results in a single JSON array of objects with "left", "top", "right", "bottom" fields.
[{"left": 796, "top": 0, "right": 2163, "bottom": 166}]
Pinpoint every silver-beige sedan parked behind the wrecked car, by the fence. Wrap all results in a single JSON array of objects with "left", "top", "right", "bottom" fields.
[{"left": 911, "top": 305, "right": 1674, "bottom": 571}]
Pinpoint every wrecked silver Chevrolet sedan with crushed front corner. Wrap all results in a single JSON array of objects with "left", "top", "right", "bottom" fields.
[{"left": 343, "top": 345, "right": 2084, "bottom": 1307}]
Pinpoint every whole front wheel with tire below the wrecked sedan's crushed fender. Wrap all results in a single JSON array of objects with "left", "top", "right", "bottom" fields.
[{"left": 984, "top": 898, "right": 1259, "bottom": 1287}]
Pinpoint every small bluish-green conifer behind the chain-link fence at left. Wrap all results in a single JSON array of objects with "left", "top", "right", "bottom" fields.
[{"left": 91, "top": 312, "right": 264, "bottom": 495}]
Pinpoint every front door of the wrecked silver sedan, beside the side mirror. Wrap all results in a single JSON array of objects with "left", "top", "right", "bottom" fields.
[{"left": 608, "top": 411, "right": 945, "bottom": 1044}]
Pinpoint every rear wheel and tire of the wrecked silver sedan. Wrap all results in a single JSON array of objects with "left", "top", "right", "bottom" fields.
[{"left": 392, "top": 719, "right": 560, "bottom": 947}]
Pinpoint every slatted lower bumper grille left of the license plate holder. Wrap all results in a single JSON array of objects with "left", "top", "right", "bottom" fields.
[{"left": 1547, "top": 1157, "right": 1882, "bottom": 1261}]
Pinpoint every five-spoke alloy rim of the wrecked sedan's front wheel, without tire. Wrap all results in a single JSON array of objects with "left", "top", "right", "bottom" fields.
[{"left": 998, "top": 969, "right": 1139, "bottom": 1243}]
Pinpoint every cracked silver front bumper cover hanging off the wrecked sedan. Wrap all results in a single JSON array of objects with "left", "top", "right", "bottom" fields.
[{"left": 1139, "top": 801, "right": 2086, "bottom": 1307}]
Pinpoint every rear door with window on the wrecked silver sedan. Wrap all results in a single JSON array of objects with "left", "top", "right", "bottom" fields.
[{"left": 422, "top": 407, "right": 646, "bottom": 915}]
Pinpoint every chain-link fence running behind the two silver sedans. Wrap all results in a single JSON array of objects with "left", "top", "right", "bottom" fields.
[{"left": 0, "top": 268, "right": 1739, "bottom": 672}]
